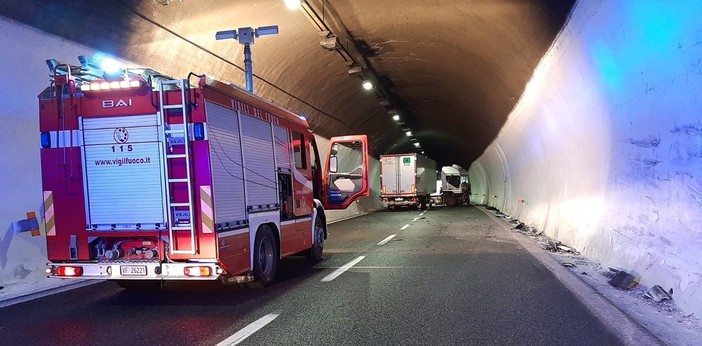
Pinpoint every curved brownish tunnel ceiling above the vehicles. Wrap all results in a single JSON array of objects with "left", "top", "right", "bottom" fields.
[{"left": 0, "top": 0, "right": 574, "bottom": 167}]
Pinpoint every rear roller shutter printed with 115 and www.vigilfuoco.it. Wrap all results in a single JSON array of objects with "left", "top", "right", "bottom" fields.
[{"left": 82, "top": 114, "right": 164, "bottom": 229}]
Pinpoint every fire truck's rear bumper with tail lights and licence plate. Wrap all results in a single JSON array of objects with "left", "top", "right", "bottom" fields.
[{"left": 46, "top": 261, "right": 224, "bottom": 280}]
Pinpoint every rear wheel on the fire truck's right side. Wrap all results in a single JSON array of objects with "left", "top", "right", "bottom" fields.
[{"left": 251, "top": 225, "right": 278, "bottom": 287}]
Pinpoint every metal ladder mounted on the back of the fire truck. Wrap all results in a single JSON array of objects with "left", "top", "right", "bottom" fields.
[{"left": 159, "top": 79, "right": 196, "bottom": 255}]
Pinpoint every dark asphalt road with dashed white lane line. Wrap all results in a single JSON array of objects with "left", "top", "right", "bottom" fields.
[{"left": 0, "top": 206, "right": 621, "bottom": 345}]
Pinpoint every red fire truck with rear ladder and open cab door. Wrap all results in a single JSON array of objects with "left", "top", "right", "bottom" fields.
[{"left": 39, "top": 58, "right": 368, "bottom": 288}]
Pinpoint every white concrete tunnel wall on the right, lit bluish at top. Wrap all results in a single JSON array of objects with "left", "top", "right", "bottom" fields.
[{"left": 470, "top": 1, "right": 702, "bottom": 316}]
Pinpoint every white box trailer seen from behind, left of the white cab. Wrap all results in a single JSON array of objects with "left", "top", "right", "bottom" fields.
[{"left": 380, "top": 153, "right": 436, "bottom": 210}]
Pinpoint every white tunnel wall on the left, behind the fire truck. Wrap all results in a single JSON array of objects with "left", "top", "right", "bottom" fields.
[{"left": 0, "top": 17, "right": 382, "bottom": 290}]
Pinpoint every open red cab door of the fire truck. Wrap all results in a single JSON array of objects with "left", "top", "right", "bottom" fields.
[{"left": 322, "top": 135, "right": 369, "bottom": 209}]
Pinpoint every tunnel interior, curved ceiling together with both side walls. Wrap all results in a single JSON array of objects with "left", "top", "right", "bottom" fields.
[{"left": 0, "top": 0, "right": 702, "bottom": 315}]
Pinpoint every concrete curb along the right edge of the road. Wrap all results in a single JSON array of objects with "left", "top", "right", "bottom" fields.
[{"left": 476, "top": 206, "right": 665, "bottom": 345}]
